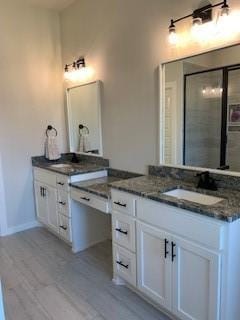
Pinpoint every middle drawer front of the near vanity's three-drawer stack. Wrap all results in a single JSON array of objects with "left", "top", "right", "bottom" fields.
[{"left": 112, "top": 213, "right": 136, "bottom": 252}]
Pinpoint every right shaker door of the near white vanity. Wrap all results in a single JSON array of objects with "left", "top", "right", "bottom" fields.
[{"left": 172, "top": 238, "right": 221, "bottom": 320}]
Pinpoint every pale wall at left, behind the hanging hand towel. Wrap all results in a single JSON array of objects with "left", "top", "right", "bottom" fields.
[{"left": 0, "top": 0, "right": 66, "bottom": 233}]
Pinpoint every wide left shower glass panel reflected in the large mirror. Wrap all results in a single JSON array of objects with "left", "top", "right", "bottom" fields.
[{"left": 183, "top": 70, "right": 223, "bottom": 169}]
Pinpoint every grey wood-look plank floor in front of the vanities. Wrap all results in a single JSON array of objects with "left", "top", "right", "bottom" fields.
[{"left": 0, "top": 228, "right": 172, "bottom": 320}]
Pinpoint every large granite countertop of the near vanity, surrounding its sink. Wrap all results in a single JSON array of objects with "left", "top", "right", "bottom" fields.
[{"left": 110, "top": 175, "right": 240, "bottom": 222}]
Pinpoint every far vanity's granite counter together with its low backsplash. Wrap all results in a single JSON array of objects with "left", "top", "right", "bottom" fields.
[{"left": 32, "top": 154, "right": 109, "bottom": 176}]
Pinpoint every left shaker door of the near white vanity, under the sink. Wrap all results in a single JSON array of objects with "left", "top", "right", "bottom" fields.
[{"left": 137, "top": 222, "right": 172, "bottom": 310}]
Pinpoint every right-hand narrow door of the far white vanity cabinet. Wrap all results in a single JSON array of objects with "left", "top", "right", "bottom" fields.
[{"left": 45, "top": 186, "right": 59, "bottom": 232}]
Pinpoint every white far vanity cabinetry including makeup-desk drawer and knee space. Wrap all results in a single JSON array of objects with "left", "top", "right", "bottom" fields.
[{"left": 33, "top": 167, "right": 111, "bottom": 252}]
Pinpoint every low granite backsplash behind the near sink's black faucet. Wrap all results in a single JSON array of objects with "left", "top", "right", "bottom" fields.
[{"left": 148, "top": 166, "right": 240, "bottom": 191}]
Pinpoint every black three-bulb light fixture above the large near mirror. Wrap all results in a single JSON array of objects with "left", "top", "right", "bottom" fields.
[{"left": 168, "top": 0, "right": 230, "bottom": 44}]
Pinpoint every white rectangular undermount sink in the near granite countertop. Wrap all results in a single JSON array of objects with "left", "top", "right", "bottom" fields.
[{"left": 163, "top": 189, "right": 224, "bottom": 206}]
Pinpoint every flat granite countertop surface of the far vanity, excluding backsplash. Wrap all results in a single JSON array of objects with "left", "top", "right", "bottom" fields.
[{"left": 33, "top": 161, "right": 108, "bottom": 176}]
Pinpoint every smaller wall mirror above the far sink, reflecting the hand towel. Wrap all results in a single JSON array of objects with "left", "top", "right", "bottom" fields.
[{"left": 67, "top": 81, "right": 103, "bottom": 156}]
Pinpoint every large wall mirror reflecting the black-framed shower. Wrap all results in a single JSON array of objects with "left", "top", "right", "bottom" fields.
[{"left": 160, "top": 45, "right": 240, "bottom": 172}]
